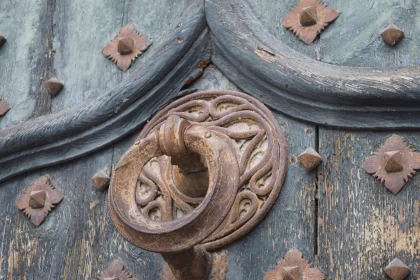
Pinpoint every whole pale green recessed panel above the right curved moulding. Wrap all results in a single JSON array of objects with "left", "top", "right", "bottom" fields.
[{"left": 247, "top": 0, "right": 420, "bottom": 67}]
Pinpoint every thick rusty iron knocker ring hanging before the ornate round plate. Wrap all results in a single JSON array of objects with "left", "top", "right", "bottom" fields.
[{"left": 109, "top": 116, "right": 239, "bottom": 252}]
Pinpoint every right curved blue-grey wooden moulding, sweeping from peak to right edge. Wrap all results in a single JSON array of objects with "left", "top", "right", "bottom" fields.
[{"left": 206, "top": 0, "right": 420, "bottom": 129}]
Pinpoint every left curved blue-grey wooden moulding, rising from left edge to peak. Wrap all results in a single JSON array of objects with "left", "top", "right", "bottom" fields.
[{"left": 0, "top": 1, "right": 210, "bottom": 184}]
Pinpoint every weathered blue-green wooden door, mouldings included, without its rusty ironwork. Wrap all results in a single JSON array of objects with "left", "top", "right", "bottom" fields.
[{"left": 0, "top": 0, "right": 420, "bottom": 280}]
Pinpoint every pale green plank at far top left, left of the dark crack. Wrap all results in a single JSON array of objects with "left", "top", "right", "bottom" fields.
[{"left": 0, "top": 0, "right": 45, "bottom": 130}]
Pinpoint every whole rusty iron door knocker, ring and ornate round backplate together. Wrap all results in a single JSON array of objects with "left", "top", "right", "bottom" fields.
[{"left": 109, "top": 91, "right": 287, "bottom": 278}]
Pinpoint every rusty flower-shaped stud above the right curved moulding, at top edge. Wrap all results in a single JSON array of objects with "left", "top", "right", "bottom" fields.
[{"left": 282, "top": 0, "right": 339, "bottom": 45}]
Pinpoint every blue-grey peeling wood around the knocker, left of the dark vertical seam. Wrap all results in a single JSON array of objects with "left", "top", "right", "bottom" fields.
[{"left": 0, "top": 66, "right": 316, "bottom": 280}]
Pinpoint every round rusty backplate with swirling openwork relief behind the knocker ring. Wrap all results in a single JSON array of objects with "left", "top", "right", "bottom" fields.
[{"left": 136, "top": 90, "right": 287, "bottom": 250}]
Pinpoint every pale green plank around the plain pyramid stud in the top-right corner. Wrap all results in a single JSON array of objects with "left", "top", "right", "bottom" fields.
[{"left": 321, "top": 0, "right": 420, "bottom": 67}]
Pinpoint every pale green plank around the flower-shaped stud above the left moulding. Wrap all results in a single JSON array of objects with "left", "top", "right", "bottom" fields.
[{"left": 52, "top": 0, "right": 188, "bottom": 112}]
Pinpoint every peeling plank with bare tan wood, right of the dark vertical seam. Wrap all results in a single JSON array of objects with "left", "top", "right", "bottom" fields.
[{"left": 318, "top": 128, "right": 420, "bottom": 280}]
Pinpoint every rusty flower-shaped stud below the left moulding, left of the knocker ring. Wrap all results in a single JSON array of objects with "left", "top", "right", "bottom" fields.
[{"left": 16, "top": 176, "right": 64, "bottom": 226}]
